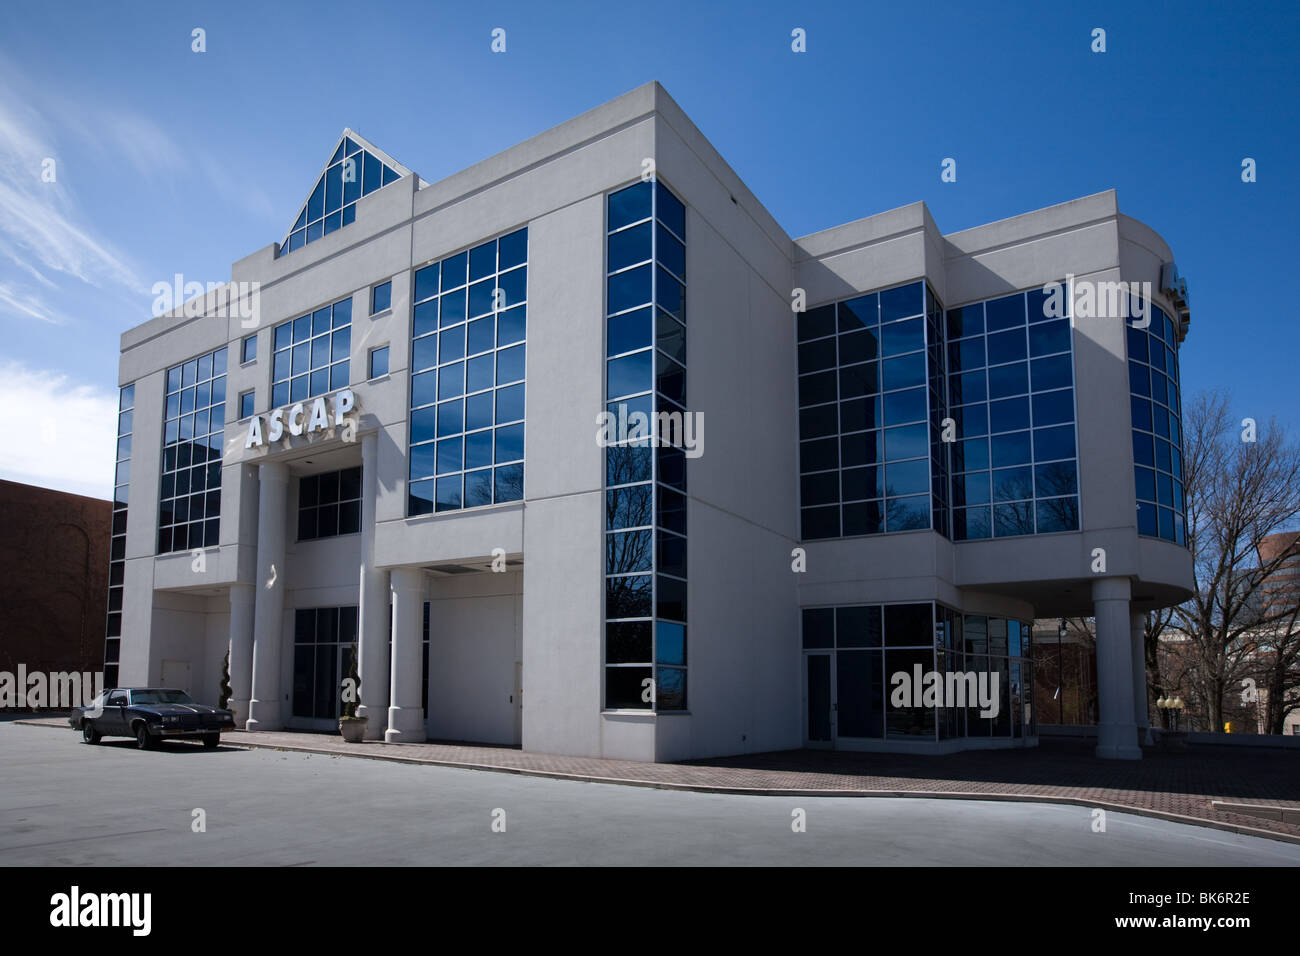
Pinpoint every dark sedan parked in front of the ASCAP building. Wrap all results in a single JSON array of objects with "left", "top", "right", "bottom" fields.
[{"left": 68, "top": 687, "right": 235, "bottom": 750}]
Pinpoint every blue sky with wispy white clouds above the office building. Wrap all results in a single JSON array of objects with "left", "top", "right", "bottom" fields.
[{"left": 0, "top": 1, "right": 1300, "bottom": 497}]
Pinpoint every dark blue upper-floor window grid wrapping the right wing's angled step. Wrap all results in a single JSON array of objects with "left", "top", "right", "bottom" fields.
[{"left": 798, "top": 282, "right": 1079, "bottom": 541}]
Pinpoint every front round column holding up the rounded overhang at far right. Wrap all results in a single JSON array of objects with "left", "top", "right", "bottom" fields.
[{"left": 1092, "top": 578, "right": 1141, "bottom": 760}]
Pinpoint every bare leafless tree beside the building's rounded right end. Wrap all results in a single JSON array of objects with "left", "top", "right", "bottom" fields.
[{"left": 1170, "top": 390, "right": 1300, "bottom": 731}]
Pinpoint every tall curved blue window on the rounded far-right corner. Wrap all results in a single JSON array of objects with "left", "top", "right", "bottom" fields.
[{"left": 1127, "top": 302, "right": 1187, "bottom": 546}]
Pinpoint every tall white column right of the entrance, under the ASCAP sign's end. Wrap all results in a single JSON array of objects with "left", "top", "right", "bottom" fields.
[{"left": 356, "top": 432, "right": 391, "bottom": 740}]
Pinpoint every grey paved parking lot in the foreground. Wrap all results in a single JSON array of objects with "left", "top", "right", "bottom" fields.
[{"left": 0, "top": 723, "right": 1300, "bottom": 866}]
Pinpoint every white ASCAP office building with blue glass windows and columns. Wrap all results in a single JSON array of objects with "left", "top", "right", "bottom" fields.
[{"left": 105, "top": 83, "right": 1192, "bottom": 761}]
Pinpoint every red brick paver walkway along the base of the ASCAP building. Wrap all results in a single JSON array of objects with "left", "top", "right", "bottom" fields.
[{"left": 22, "top": 721, "right": 1300, "bottom": 843}]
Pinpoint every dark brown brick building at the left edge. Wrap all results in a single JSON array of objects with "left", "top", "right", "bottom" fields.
[{"left": 0, "top": 481, "right": 110, "bottom": 697}]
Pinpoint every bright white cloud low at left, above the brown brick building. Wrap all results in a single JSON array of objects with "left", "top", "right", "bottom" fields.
[{"left": 0, "top": 362, "right": 117, "bottom": 498}]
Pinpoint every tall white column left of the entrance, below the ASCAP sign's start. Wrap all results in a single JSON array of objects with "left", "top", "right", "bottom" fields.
[{"left": 244, "top": 462, "right": 289, "bottom": 731}]
